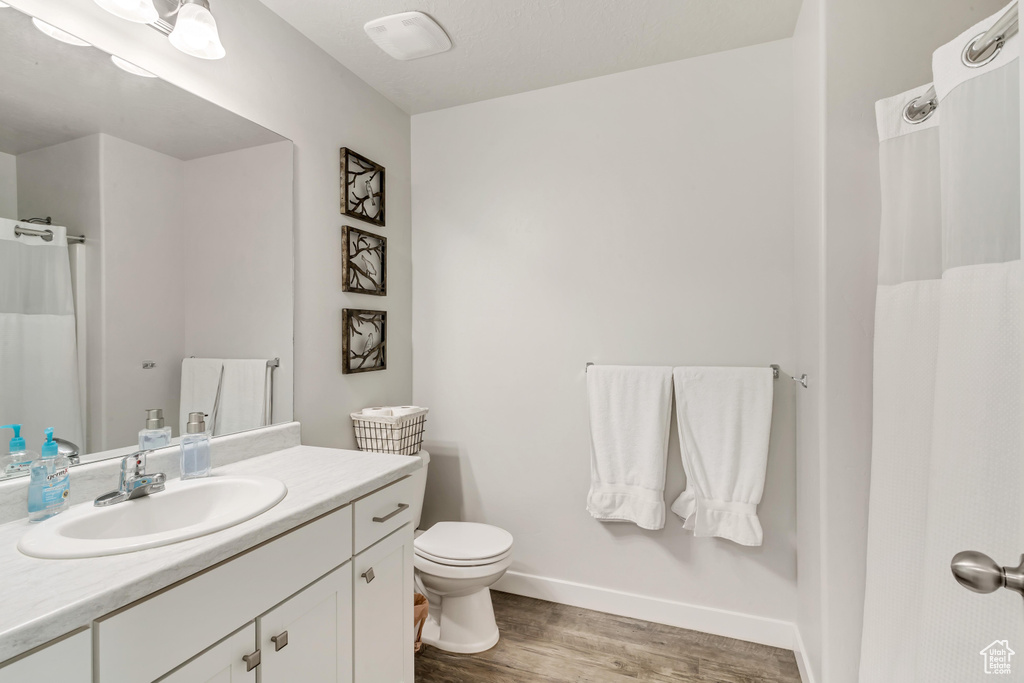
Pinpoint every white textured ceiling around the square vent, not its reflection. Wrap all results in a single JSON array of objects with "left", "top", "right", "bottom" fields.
[{"left": 262, "top": 0, "right": 800, "bottom": 114}]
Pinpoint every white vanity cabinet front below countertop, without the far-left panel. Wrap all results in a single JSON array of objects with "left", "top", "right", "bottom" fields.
[{"left": 80, "top": 477, "right": 414, "bottom": 683}]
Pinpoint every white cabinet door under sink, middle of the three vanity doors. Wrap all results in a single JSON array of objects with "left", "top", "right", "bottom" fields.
[{"left": 257, "top": 562, "right": 352, "bottom": 683}]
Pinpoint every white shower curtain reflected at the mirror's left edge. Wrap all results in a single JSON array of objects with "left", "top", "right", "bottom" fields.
[{"left": 0, "top": 218, "right": 85, "bottom": 454}]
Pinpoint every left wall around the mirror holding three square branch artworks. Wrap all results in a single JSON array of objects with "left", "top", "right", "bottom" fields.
[{"left": 10, "top": 0, "right": 412, "bottom": 454}]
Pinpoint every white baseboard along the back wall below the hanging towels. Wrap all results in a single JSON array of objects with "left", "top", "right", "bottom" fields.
[{"left": 494, "top": 571, "right": 798, "bottom": 651}]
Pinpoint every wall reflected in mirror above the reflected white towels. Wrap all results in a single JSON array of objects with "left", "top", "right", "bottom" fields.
[{"left": 182, "top": 141, "right": 295, "bottom": 431}]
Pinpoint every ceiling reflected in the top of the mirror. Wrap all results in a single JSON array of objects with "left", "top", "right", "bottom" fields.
[{"left": 0, "top": 9, "right": 285, "bottom": 160}]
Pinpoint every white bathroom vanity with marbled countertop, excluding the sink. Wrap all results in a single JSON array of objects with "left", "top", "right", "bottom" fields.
[{"left": 0, "top": 445, "right": 421, "bottom": 683}]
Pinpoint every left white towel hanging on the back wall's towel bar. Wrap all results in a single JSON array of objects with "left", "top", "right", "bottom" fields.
[{"left": 587, "top": 366, "right": 672, "bottom": 529}]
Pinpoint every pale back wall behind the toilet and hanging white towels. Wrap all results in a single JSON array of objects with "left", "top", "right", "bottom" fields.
[{"left": 413, "top": 41, "right": 797, "bottom": 644}]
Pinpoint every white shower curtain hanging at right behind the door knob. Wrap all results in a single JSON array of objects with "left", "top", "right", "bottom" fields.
[{"left": 860, "top": 3, "right": 1024, "bottom": 683}]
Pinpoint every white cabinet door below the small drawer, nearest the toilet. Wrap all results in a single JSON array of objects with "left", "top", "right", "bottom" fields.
[{"left": 352, "top": 524, "right": 414, "bottom": 683}]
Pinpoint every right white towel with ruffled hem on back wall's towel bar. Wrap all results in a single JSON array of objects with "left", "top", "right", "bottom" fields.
[{"left": 672, "top": 368, "right": 774, "bottom": 546}]
